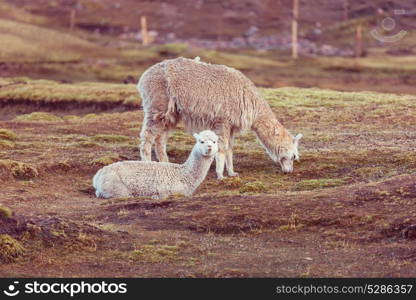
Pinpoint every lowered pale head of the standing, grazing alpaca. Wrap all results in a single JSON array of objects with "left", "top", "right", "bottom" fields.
[{"left": 275, "top": 133, "right": 303, "bottom": 173}]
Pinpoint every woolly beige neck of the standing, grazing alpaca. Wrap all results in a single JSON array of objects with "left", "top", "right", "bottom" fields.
[{"left": 252, "top": 109, "right": 289, "bottom": 161}]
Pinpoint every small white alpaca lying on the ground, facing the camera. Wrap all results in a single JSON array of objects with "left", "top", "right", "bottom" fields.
[{"left": 93, "top": 130, "right": 218, "bottom": 198}]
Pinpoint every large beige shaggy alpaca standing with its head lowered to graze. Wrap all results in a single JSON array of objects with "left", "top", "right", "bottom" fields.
[{"left": 137, "top": 57, "right": 302, "bottom": 179}]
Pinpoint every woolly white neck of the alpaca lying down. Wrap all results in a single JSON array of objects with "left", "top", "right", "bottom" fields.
[{"left": 183, "top": 148, "right": 214, "bottom": 190}]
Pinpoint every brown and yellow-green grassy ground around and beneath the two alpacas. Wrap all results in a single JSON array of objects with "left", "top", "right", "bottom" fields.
[{"left": 0, "top": 84, "right": 416, "bottom": 277}]
